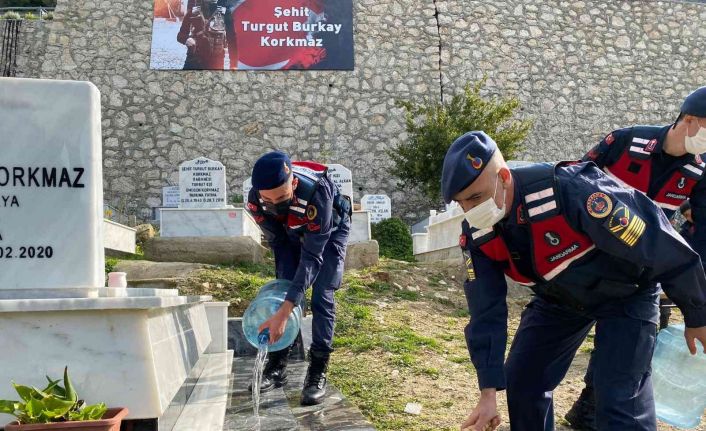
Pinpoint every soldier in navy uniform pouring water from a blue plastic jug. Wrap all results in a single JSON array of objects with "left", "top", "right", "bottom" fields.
[{"left": 247, "top": 151, "right": 352, "bottom": 405}]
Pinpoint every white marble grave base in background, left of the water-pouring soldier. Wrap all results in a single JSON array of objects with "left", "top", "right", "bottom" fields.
[{"left": 160, "top": 208, "right": 261, "bottom": 244}]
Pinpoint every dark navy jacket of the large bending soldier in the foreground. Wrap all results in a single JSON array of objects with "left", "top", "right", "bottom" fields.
[{"left": 461, "top": 163, "right": 706, "bottom": 389}]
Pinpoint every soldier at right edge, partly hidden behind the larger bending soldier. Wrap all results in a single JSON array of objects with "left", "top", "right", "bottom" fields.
[{"left": 566, "top": 87, "right": 706, "bottom": 431}]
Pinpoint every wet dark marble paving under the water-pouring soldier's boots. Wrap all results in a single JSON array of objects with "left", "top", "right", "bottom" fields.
[{"left": 223, "top": 357, "right": 375, "bottom": 431}]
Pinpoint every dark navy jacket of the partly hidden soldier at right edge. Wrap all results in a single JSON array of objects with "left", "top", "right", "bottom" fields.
[{"left": 583, "top": 126, "right": 706, "bottom": 260}]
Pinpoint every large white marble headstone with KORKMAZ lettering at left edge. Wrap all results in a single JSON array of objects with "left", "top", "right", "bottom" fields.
[{"left": 0, "top": 78, "right": 104, "bottom": 290}]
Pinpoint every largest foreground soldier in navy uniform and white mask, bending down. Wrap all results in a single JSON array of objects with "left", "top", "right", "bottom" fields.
[{"left": 441, "top": 132, "right": 706, "bottom": 431}]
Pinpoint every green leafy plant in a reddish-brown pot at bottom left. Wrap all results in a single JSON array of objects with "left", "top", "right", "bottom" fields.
[{"left": 0, "top": 368, "right": 128, "bottom": 431}]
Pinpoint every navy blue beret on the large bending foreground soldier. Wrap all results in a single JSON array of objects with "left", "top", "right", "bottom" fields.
[{"left": 441, "top": 132, "right": 498, "bottom": 203}]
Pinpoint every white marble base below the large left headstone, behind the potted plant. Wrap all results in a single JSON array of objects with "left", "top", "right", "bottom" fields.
[{"left": 0, "top": 298, "right": 211, "bottom": 423}]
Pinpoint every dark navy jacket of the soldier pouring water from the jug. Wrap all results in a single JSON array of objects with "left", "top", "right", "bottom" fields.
[{"left": 248, "top": 167, "right": 350, "bottom": 304}]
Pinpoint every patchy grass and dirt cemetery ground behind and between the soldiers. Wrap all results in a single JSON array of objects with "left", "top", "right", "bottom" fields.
[{"left": 108, "top": 258, "right": 706, "bottom": 431}]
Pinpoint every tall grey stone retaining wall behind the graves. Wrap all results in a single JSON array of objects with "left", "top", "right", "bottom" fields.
[{"left": 5, "top": 0, "right": 706, "bottom": 220}]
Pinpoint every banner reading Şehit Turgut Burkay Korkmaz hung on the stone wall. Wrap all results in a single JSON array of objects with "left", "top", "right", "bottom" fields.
[{"left": 150, "top": 0, "right": 354, "bottom": 70}]
